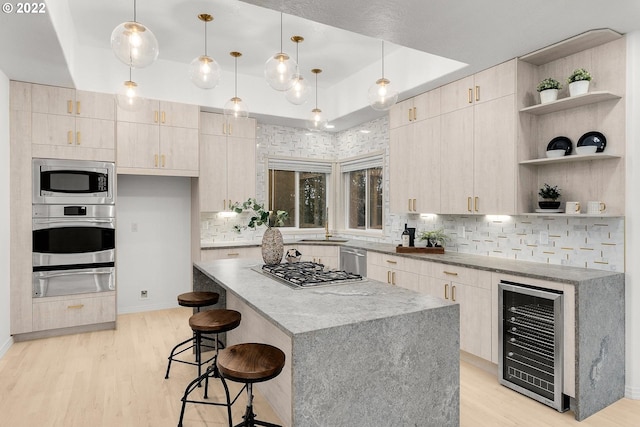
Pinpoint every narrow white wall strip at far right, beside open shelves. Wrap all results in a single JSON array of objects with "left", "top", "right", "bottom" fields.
[{"left": 625, "top": 31, "right": 640, "bottom": 399}]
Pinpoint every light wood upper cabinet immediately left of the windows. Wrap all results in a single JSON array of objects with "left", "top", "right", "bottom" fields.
[{"left": 198, "top": 112, "right": 256, "bottom": 212}]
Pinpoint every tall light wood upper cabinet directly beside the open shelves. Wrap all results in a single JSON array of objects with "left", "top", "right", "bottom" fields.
[{"left": 440, "top": 61, "right": 517, "bottom": 214}]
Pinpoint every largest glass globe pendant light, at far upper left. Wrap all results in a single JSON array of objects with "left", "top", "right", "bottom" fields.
[{"left": 111, "top": 0, "right": 158, "bottom": 68}]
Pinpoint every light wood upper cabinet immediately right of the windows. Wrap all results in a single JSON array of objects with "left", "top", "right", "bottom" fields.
[{"left": 389, "top": 89, "right": 441, "bottom": 213}]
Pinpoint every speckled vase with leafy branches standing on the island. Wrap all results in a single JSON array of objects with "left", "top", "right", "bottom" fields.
[{"left": 231, "top": 198, "right": 289, "bottom": 265}]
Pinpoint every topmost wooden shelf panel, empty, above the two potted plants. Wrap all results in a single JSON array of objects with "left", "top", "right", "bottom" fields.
[{"left": 520, "top": 28, "right": 622, "bottom": 65}]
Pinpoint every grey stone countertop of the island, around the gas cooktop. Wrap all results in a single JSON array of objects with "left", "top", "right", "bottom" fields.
[{"left": 194, "top": 258, "right": 452, "bottom": 336}]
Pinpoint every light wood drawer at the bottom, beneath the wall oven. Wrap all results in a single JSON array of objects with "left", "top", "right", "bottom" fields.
[{"left": 33, "top": 292, "right": 116, "bottom": 331}]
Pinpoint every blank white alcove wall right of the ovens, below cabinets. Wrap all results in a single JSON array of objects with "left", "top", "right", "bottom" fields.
[{"left": 116, "top": 175, "right": 191, "bottom": 313}]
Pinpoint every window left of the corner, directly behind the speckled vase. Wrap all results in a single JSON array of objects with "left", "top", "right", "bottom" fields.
[{"left": 269, "top": 159, "right": 331, "bottom": 228}]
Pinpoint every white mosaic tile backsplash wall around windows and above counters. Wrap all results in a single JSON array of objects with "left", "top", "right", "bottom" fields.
[{"left": 201, "top": 117, "right": 624, "bottom": 271}]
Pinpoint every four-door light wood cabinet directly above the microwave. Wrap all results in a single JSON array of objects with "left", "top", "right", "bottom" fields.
[{"left": 31, "top": 85, "right": 115, "bottom": 161}]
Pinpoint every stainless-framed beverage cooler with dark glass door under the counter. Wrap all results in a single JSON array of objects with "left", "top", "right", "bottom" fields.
[{"left": 498, "top": 281, "right": 569, "bottom": 412}]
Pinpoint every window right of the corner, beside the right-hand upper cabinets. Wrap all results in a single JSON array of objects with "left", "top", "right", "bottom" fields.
[{"left": 342, "top": 155, "right": 384, "bottom": 230}]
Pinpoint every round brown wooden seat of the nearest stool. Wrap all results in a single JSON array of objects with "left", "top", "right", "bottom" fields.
[{"left": 217, "top": 343, "right": 285, "bottom": 383}]
